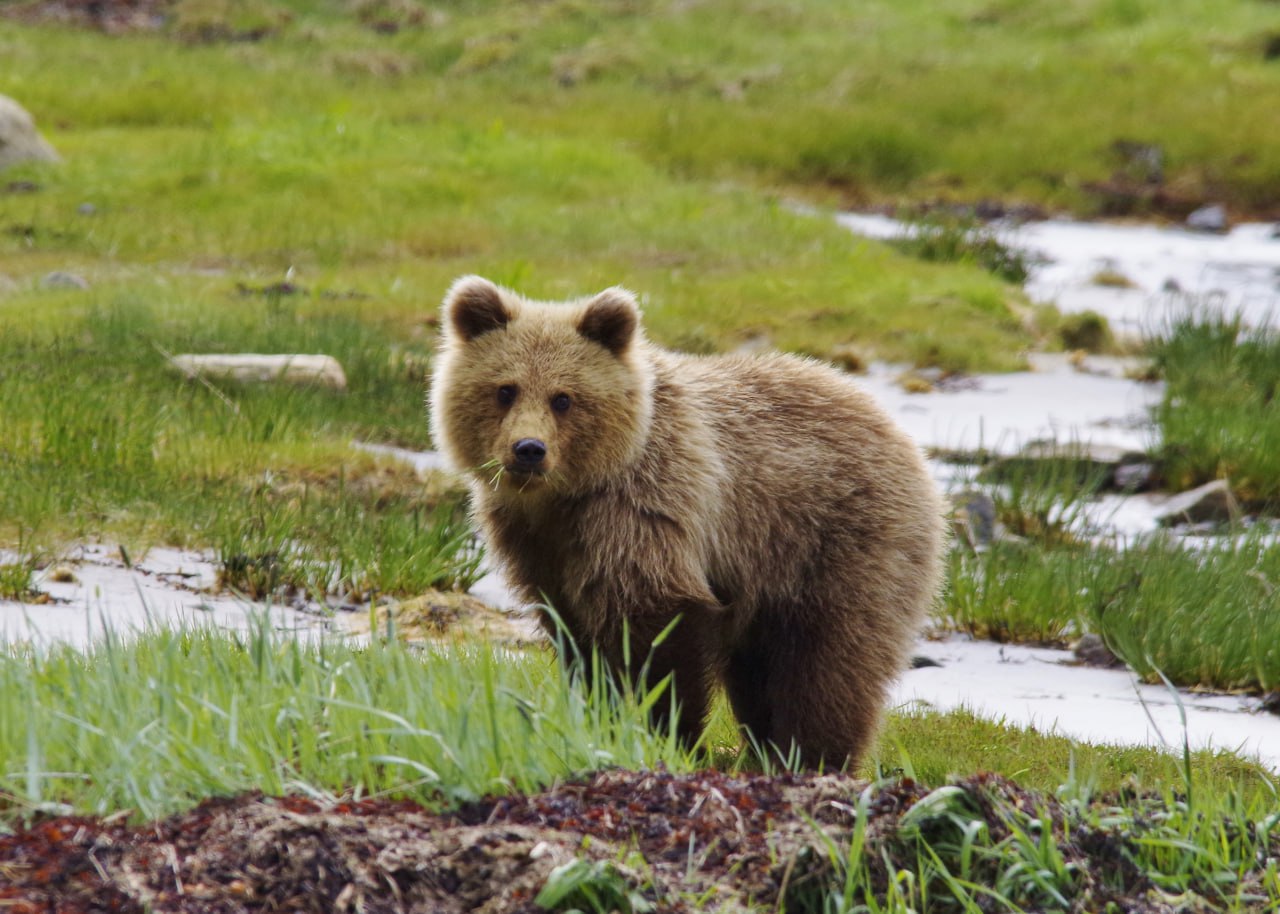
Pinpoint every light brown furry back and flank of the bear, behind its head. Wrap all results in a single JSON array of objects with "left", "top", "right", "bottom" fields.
[{"left": 654, "top": 353, "right": 942, "bottom": 611}]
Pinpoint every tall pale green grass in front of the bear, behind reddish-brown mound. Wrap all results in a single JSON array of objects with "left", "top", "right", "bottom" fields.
[{"left": 0, "top": 618, "right": 690, "bottom": 821}]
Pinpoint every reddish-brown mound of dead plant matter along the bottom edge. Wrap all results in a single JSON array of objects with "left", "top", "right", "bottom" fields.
[{"left": 0, "top": 771, "right": 1249, "bottom": 914}]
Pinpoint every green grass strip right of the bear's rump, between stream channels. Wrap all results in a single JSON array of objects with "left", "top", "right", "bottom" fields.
[{"left": 940, "top": 535, "right": 1280, "bottom": 691}]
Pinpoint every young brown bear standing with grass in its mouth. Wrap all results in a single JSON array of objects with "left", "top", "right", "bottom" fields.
[{"left": 430, "top": 277, "right": 943, "bottom": 766}]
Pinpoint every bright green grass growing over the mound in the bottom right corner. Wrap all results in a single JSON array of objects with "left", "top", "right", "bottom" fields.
[{"left": 786, "top": 762, "right": 1280, "bottom": 914}]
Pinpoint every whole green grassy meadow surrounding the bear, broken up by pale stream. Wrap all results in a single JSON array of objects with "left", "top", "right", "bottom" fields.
[{"left": 0, "top": 0, "right": 1280, "bottom": 911}]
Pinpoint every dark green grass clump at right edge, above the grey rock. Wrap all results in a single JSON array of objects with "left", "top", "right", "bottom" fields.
[{"left": 1151, "top": 312, "right": 1280, "bottom": 508}]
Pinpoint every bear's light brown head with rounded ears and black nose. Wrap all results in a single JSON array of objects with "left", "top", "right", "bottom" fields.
[{"left": 430, "top": 277, "right": 653, "bottom": 498}]
